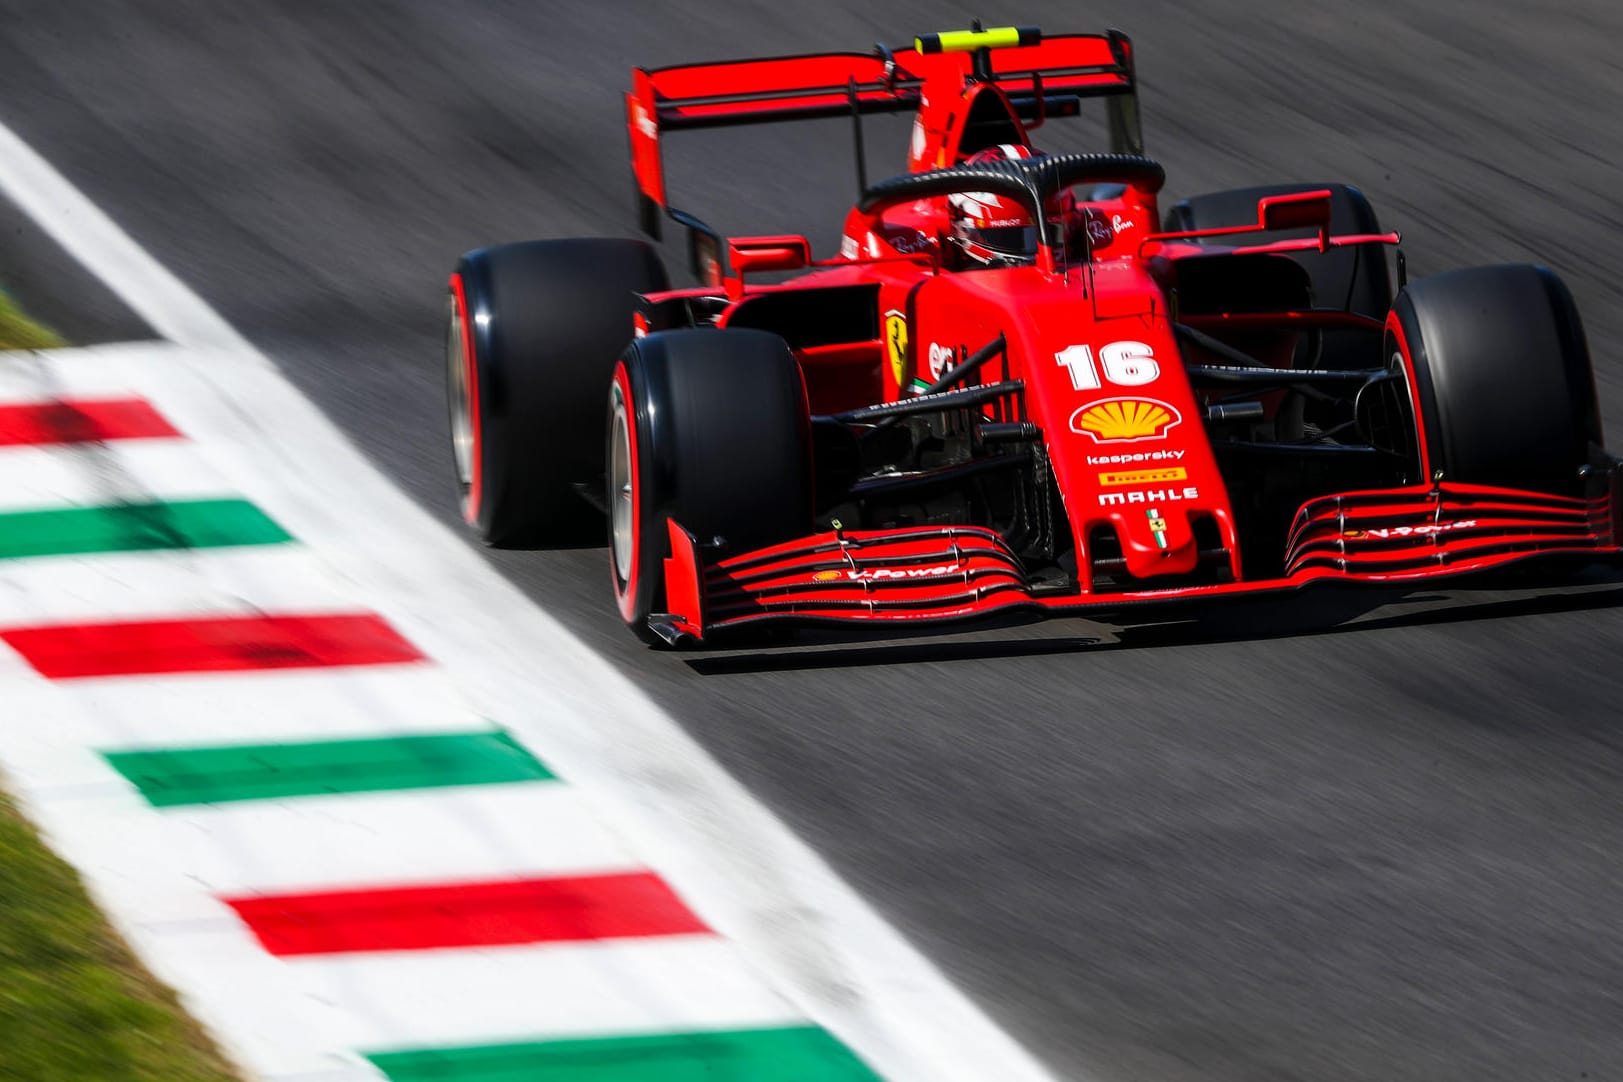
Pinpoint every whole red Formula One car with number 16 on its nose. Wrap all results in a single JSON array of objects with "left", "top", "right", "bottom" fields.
[{"left": 446, "top": 28, "right": 1623, "bottom": 642}]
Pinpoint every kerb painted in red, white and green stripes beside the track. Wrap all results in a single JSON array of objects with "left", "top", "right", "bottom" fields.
[{"left": 0, "top": 384, "right": 880, "bottom": 1082}]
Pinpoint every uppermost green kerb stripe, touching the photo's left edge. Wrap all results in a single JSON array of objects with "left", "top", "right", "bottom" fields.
[{"left": 0, "top": 500, "right": 291, "bottom": 558}]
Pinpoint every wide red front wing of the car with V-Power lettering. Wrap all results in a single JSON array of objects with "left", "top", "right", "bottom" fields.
[{"left": 649, "top": 464, "right": 1623, "bottom": 642}]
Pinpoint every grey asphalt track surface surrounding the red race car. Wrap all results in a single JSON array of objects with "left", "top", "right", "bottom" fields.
[{"left": 0, "top": 0, "right": 1623, "bottom": 1080}]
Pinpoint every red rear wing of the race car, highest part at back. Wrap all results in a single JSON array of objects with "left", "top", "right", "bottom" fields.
[{"left": 625, "top": 26, "right": 1144, "bottom": 249}]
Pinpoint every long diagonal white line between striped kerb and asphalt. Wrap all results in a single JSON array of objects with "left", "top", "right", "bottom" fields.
[{"left": 0, "top": 114, "right": 1050, "bottom": 1082}]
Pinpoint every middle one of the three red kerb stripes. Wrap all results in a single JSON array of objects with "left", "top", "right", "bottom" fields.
[{"left": 0, "top": 615, "right": 422, "bottom": 680}]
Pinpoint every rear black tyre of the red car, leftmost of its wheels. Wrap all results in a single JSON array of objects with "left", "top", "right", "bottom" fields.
[{"left": 445, "top": 238, "right": 669, "bottom": 548}]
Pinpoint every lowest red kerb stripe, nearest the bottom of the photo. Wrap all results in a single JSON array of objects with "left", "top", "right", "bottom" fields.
[{"left": 226, "top": 873, "right": 709, "bottom": 955}]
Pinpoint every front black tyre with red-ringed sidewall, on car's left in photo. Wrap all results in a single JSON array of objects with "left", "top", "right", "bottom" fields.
[{"left": 605, "top": 329, "right": 812, "bottom": 646}]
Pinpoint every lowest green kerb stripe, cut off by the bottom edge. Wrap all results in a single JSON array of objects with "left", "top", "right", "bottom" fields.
[{"left": 367, "top": 1025, "right": 880, "bottom": 1082}]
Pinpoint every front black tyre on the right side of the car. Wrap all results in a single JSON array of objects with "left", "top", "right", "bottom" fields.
[{"left": 1386, "top": 264, "right": 1602, "bottom": 495}]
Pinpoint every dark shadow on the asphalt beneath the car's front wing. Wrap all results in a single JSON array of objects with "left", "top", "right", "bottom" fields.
[{"left": 683, "top": 569, "right": 1623, "bottom": 676}]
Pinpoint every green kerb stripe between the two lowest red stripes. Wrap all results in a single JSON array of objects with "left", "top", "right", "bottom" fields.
[{"left": 105, "top": 732, "right": 553, "bottom": 808}]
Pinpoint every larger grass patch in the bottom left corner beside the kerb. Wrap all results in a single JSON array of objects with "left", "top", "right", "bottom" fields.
[{"left": 0, "top": 792, "right": 235, "bottom": 1082}]
